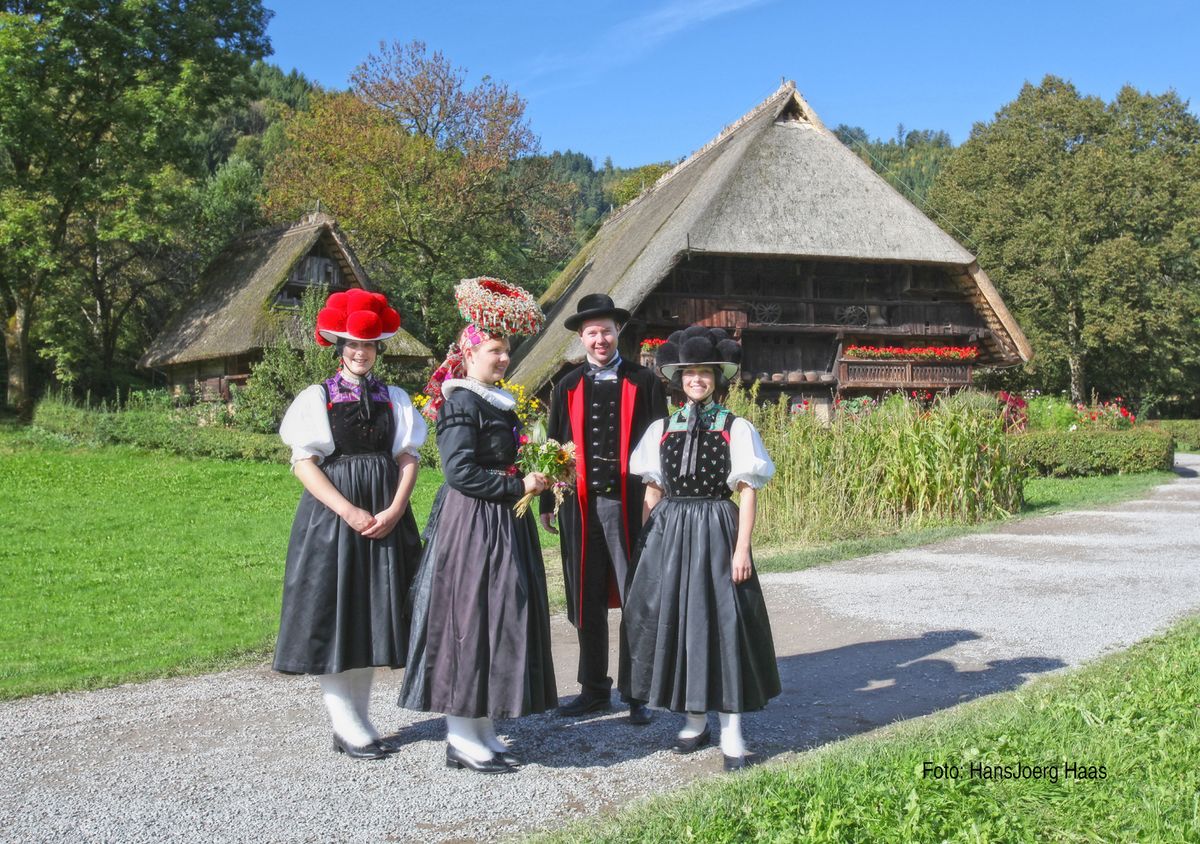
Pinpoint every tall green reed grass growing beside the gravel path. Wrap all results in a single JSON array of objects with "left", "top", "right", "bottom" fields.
[{"left": 726, "top": 385, "right": 1025, "bottom": 545}]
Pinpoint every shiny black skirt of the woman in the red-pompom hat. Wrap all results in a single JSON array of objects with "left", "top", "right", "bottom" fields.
[{"left": 275, "top": 454, "right": 421, "bottom": 674}]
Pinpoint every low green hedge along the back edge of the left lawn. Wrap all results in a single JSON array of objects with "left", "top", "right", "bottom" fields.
[{"left": 34, "top": 399, "right": 290, "bottom": 463}]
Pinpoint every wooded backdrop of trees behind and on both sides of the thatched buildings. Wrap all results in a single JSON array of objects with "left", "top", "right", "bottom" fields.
[{"left": 0, "top": 0, "right": 1200, "bottom": 414}]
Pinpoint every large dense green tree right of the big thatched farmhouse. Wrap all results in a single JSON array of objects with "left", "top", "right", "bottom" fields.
[{"left": 930, "top": 77, "right": 1200, "bottom": 407}]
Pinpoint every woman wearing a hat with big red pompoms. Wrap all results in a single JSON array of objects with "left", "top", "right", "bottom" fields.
[{"left": 275, "top": 289, "right": 426, "bottom": 759}]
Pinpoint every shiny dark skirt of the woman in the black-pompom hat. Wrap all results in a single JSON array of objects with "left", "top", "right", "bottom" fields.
[{"left": 622, "top": 498, "right": 780, "bottom": 712}]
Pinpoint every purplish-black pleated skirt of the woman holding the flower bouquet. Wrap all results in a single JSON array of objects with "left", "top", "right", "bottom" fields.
[{"left": 400, "top": 485, "right": 558, "bottom": 718}]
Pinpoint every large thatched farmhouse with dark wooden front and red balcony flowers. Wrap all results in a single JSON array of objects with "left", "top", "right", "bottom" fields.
[{"left": 509, "top": 83, "right": 1032, "bottom": 398}]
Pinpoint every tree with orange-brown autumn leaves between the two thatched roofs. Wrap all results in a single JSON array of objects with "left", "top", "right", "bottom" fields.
[{"left": 266, "top": 42, "right": 571, "bottom": 346}]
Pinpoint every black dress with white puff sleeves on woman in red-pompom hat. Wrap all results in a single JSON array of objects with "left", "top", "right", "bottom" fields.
[{"left": 275, "top": 378, "right": 425, "bottom": 674}]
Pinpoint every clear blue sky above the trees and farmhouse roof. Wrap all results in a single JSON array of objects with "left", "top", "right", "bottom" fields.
[{"left": 265, "top": 0, "right": 1200, "bottom": 167}]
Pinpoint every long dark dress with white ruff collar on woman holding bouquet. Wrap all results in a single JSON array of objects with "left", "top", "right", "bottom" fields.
[{"left": 400, "top": 381, "right": 558, "bottom": 718}]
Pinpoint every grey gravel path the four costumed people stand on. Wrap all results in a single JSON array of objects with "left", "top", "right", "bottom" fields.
[{"left": 0, "top": 455, "right": 1200, "bottom": 842}]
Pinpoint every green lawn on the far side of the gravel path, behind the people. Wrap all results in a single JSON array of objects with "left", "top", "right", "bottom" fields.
[{"left": 0, "top": 421, "right": 1174, "bottom": 698}]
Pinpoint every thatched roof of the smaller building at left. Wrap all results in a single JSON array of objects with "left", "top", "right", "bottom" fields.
[{"left": 138, "top": 214, "right": 430, "bottom": 369}]
